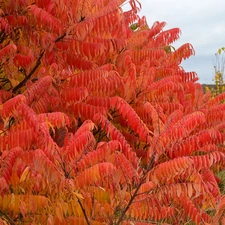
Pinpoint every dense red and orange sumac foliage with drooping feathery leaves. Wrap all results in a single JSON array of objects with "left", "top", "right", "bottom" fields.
[{"left": 0, "top": 0, "right": 225, "bottom": 225}]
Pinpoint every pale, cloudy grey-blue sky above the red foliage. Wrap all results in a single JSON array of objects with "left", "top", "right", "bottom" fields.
[{"left": 133, "top": 0, "right": 225, "bottom": 84}]
